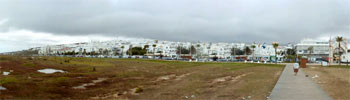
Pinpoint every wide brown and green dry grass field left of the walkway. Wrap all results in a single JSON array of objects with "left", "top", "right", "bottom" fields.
[{"left": 0, "top": 56, "right": 284, "bottom": 100}]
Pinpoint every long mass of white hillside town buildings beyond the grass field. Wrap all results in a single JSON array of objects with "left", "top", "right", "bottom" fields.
[{"left": 39, "top": 39, "right": 288, "bottom": 59}]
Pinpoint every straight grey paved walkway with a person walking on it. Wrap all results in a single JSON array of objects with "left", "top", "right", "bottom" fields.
[{"left": 269, "top": 64, "right": 333, "bottom": 100}]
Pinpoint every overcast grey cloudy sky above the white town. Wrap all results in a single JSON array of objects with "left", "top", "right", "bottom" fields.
[{"left": 0, "top": 0, "right": 350, "bottom": 52}]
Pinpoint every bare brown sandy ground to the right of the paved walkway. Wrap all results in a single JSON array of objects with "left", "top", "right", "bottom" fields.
[{"left": 303, "top": 66, "right": 350, "bottom": 100}]
